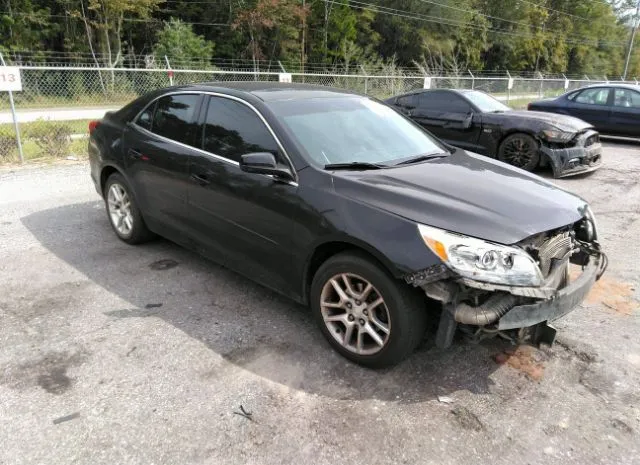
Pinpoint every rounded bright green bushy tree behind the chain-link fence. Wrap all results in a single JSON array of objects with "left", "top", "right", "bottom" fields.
[{"left": 153, "top": 18, "right": 214, "bottom": 67}]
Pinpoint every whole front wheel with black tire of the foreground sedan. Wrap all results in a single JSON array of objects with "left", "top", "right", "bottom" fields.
[{"left": 310, "top": 252, "right": 427, "bottom": 368}]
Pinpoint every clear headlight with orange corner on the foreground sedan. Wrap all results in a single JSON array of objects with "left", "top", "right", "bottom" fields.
[{"left": 418, "top": 224, "right": 543, "bottom": 286}]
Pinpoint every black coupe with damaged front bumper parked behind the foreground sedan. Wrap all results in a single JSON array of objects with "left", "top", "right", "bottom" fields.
[{"left": 386, "top": 89, "right": 602, "bottom": 177}]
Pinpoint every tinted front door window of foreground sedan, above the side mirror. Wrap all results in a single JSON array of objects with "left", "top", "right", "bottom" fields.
[{"left": 202, "top": 97, "right": 278, "bottom": 162}]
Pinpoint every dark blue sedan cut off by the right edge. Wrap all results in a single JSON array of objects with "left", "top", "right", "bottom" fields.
[{"left": 528, "top": 84, "right": 640, "bottom": 137}]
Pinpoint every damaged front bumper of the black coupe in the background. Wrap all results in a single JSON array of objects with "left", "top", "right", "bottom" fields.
[{"left": 540, "top": 130, "right": 602, "bottom": 178}]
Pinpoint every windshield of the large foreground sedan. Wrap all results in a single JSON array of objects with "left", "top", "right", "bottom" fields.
[{"left": 269, "top": 96, "right": 445, "bottom": 166}]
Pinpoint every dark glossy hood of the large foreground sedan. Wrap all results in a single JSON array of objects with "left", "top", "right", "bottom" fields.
[{"left": 333, "top": 150, "right": 587, "bottom": 244}]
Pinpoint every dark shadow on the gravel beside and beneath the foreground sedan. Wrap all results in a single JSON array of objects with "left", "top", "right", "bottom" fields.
[{"left": 22, "top": 201, "right": 506, "bottom": 402}]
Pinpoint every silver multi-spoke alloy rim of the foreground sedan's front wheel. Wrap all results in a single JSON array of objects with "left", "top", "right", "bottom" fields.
[{"left": 320, "top": 273, "right": 391, "bottom": 355}]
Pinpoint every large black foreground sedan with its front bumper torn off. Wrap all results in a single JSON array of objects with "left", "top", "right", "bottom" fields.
[{"left": 89, "top": 82, "right": 606, "bottom": 367}]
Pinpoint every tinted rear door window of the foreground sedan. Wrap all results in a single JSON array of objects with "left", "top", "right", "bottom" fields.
[{"left": 151, "top": 94, "right": 200, "bottom": 145}]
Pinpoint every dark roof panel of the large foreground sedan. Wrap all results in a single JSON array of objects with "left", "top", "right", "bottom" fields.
[{"left": 156, "top": 81, "right": 362, "bottom": 102}]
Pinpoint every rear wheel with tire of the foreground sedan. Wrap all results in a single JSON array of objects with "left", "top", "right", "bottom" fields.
[{"left": 104, "top": 173, "right": 155, "bottom": 245}]
